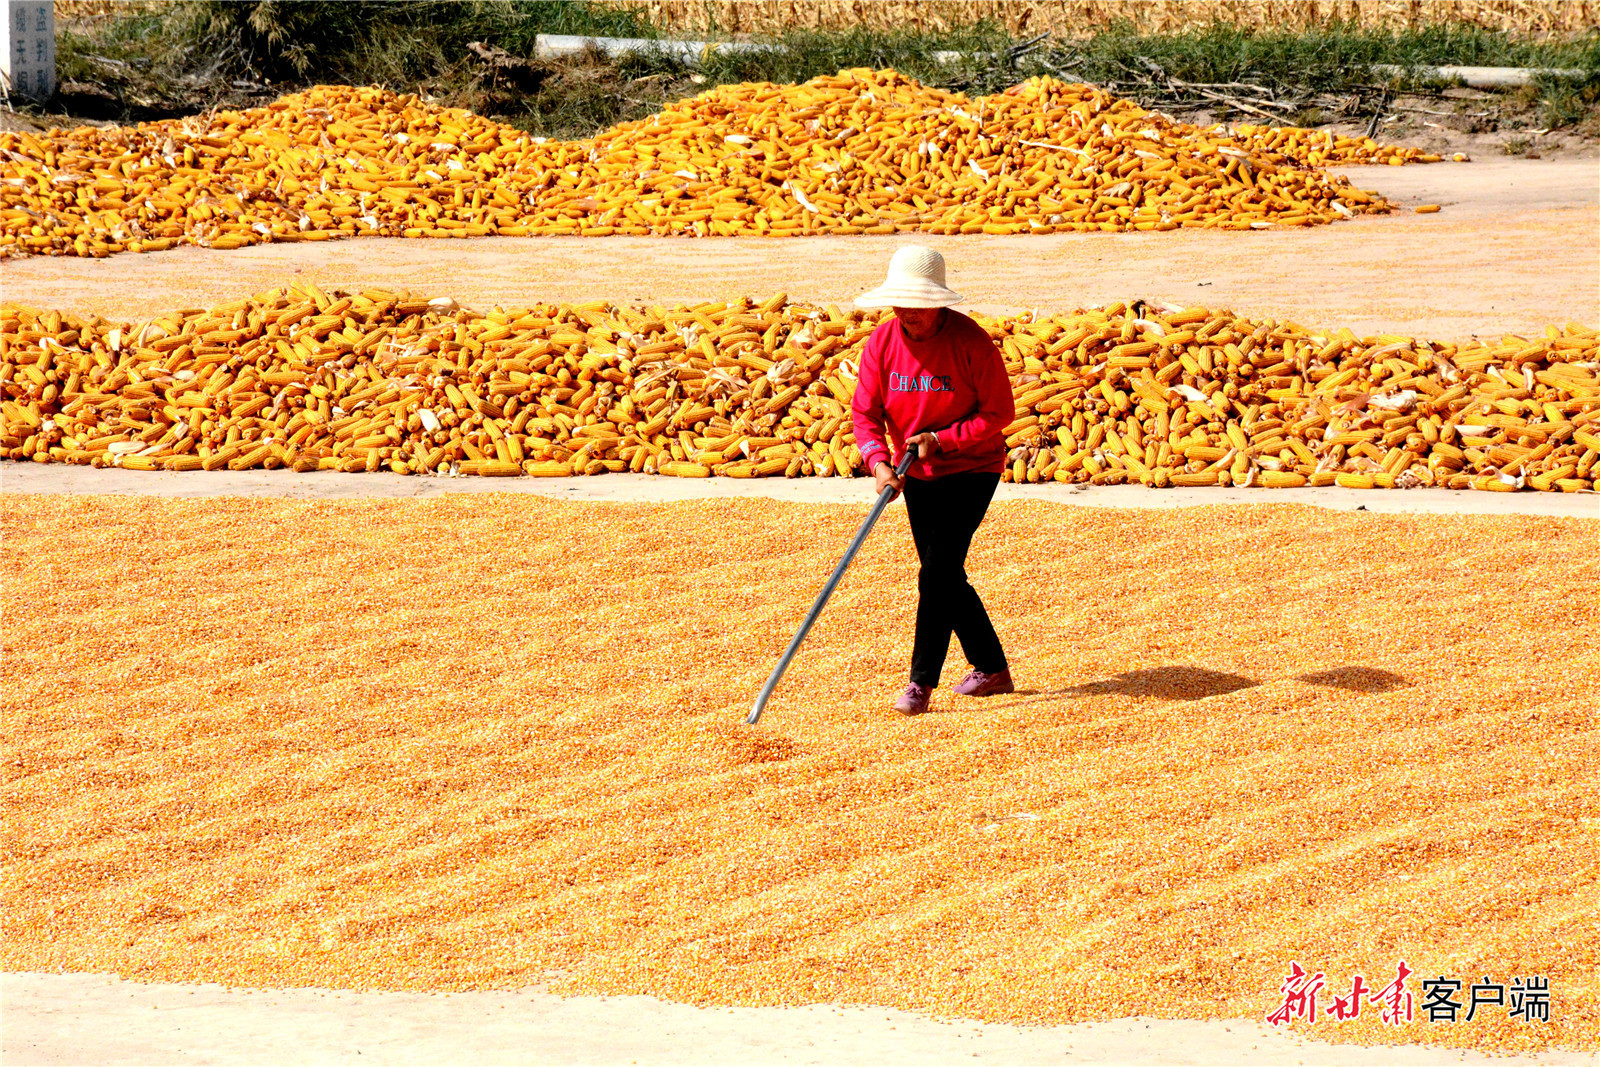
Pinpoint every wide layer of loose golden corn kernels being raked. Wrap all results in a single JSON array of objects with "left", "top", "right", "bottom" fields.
[{"left": 0, "top": 490, "right": 1600, "bottom": 1049}]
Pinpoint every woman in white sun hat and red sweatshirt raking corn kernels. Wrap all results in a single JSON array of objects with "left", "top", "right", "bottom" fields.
[{"left": 853, "top": 245, "right": 1013, "bottom": 715}]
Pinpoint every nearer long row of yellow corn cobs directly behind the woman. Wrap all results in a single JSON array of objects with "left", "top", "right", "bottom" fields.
[{"left": 0, "top": 286, "right": 1600, "bottom": 491}]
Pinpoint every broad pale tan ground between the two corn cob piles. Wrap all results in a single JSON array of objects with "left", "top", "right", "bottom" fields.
[{"left": 0, "top": 158, "right": 1600, "bottom": 341}]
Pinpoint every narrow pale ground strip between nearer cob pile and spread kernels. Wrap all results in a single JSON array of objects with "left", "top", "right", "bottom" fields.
[{"left": 0, "top": 461, "right": 1600, "bottom": 518}]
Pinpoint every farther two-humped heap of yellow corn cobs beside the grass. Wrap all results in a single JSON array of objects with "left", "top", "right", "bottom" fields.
[{"left": 0, "top": 70, "right": 1438, "bottom": 256}]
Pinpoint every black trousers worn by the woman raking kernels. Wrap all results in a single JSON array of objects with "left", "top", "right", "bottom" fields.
[{"left": 906, "top": 470, "right": 1006, "bottom": 689}]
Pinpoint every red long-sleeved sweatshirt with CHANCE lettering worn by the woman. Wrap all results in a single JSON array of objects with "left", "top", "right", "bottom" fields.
[{"left": 851, "top": 309, "right": 1014, "bottom": 480}]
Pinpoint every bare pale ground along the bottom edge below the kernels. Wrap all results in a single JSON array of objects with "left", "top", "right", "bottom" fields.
[{"left": 0, "top": 974, "right": 1595, "bottom": 1067}]
